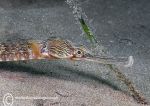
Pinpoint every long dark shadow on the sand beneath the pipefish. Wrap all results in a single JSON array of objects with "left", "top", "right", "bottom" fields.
[{"left": 0, "top": 62, "right": 121, "bottom": 91}]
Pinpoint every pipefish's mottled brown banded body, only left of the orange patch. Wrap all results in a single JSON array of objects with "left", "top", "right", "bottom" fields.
[{"left": 0, "top": 42, "right": 29, "bottom": 61}]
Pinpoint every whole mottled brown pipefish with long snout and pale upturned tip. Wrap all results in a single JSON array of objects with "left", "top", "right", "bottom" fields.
[{"left": 0, "top": 38, "right": 133, "bottom": 67}]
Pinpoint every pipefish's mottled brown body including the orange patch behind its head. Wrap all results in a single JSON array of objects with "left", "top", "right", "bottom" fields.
[{"left": 0, "top": 41, "right": 44, "bottom": 61}]
